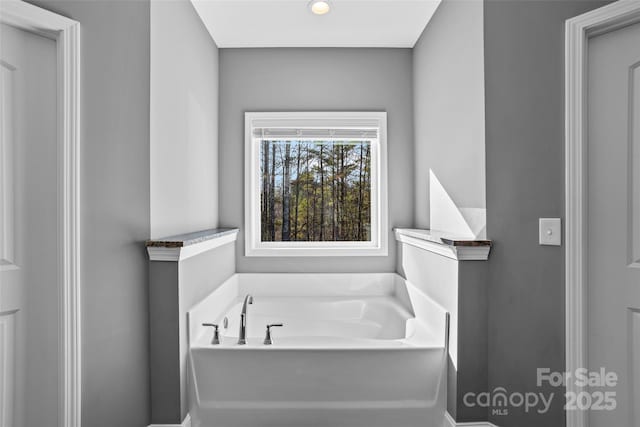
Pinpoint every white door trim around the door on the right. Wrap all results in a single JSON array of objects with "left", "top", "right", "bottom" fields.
[{"left": 565, "top": 0, "right": 640, "bottom": 427}]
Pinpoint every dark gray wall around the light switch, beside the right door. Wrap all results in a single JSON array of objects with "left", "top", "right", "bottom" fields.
[{"left": 484, "top": 0, "right": 604, "bottom": 427}]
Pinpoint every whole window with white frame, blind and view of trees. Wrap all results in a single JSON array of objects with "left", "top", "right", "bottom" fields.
[{"left": 245, "top": 112, "right": 388, "bottom": 256}]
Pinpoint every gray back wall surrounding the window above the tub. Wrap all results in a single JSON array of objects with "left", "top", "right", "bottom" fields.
[{"left": 219, "top": 49, "right": 414, "bottom": 272}]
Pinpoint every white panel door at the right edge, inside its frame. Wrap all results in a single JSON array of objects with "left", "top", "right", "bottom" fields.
[{"left": 578, "top": 18, "right": 640, "bottom": 427}]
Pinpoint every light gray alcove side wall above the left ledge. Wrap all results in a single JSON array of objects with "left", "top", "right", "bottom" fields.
[{"left": 150, "top": 0, "right": 218, "bottom": 239}]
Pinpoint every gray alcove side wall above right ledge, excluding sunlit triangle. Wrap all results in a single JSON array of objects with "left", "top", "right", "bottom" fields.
[{"left": 413, "top": 0, "right": 485, "bottom": 228}]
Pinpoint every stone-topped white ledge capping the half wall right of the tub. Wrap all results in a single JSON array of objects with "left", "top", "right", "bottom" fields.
[{"left": 393, "top": 228, "right": 491, "bottom": 261}]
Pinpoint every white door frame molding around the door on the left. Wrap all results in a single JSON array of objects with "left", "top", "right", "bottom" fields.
[{"left": 0, "top": 0, "right": 82, "bottom": 427}]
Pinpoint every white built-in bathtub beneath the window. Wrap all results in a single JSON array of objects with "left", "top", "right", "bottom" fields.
[{"left": 188, "top": 274, "right": 448, "bottom": 427}]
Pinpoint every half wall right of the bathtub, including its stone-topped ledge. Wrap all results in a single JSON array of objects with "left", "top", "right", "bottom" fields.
[{"left": 395, "top": 229, "right": 492, "bottom": 423}]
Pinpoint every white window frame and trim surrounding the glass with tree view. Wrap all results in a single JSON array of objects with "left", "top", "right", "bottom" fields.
[{"left": 245, "top": 112, "right": 389, "bottom": 257}]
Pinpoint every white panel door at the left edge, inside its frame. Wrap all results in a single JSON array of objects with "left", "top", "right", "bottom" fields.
[{"left": 0, "top": 24, "right": 61, "bottom": 427}]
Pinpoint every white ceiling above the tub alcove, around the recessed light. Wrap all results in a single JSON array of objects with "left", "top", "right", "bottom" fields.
[{"left": 191, "top": 0, "right": 440, "bottom": 48}]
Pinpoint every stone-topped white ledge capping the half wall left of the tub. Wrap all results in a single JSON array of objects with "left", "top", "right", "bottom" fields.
[{"left": 145, "top": 228, "right": 239, "bottom": 262}]
